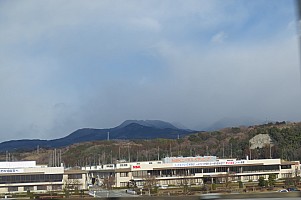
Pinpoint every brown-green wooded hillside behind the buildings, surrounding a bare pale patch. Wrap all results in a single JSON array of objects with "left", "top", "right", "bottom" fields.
[{"left": 0, "top": 122, "right": 301, "bottom": 167}]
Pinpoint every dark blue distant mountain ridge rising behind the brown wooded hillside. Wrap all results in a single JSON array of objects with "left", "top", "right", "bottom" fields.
[{"left": 0, "top": 120, "right": 196, "bottom": 152}]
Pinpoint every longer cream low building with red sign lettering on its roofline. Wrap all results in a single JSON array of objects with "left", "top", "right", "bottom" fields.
[{"left": 82, "top": 156, "right": 300, "bottom": 187}]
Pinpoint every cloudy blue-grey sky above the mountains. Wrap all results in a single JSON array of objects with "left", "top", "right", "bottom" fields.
[{"left": 0, "top": 0, "right": 301, "bottom": 142}]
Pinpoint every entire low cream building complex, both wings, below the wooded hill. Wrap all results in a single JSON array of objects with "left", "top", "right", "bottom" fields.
[{"left": 0, "top": 156, "right": 300, "bottom": 194}]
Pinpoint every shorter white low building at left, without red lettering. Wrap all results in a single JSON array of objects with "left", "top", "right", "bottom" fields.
[{"left": 0, "top": 161, "right": 87, "bottom": 194}]
